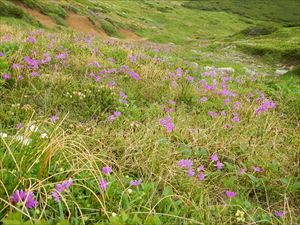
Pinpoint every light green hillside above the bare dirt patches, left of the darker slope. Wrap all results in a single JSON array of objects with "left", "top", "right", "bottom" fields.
[{"left": 0, "top": 0, "right": 253, "bottom": 44}]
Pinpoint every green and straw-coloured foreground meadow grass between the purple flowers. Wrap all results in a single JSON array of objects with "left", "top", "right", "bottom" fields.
[{"left": 0, "top": 20, "right": 299, "bottom": 225}]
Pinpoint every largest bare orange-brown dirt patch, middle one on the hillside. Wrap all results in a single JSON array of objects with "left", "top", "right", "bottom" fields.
[{"left": 66, "top": 13, "right": 108, "bottom": 38}]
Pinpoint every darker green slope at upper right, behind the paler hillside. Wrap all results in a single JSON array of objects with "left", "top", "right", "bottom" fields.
[{"left": 183, "top": 0, "right": 300, "bottom": 64}]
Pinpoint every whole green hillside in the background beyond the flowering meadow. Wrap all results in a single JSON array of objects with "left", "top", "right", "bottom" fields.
[{"left": 0, "top": 0, "right": 300, "bottom": 64}]
